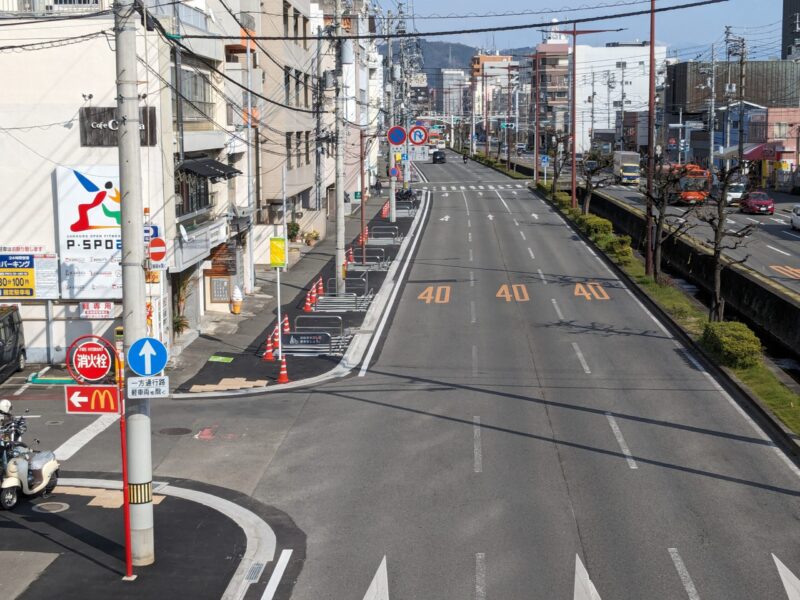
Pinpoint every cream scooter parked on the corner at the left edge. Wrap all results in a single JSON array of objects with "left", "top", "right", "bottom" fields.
[{"left": 0, "top": 400, "right": 60, "bottom": 510}]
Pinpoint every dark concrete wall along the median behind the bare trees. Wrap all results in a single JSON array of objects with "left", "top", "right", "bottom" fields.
[{"left": 592, "top": 193, "right": 800, "bottom": 352}]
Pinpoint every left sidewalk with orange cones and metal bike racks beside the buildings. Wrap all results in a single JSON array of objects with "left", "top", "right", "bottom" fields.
[{"left": 167, "top": 188, "right": 410, "bottom": 392}]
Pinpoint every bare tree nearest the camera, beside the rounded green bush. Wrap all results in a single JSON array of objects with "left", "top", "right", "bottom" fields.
[{"left": 697, "top": 165, "right": 755, "bottom": 321}]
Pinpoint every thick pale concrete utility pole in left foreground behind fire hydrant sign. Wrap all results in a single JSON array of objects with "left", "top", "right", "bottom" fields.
[{"left": 114, "top": 0, "right": 154, "bottom": 566}]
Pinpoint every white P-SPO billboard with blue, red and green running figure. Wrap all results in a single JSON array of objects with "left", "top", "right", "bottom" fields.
[{"left": 56, "top": 166, "right": 122, "bottom": 300}]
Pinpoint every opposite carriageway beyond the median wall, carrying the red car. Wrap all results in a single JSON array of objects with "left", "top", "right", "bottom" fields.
[{"left": 602, "top": 185, "right": 800, "bottom": 292}]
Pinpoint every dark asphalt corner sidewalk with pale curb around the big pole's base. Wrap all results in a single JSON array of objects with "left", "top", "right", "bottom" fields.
[{"left": 0, "top": 474, "right": 304, "bottom": 600}]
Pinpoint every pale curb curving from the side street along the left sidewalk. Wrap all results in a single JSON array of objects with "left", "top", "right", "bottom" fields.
[{"left": 170, "top": 167, "right": 431, "bottom": 400}]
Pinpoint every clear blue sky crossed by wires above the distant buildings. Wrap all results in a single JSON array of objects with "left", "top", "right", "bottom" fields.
[{"left": 379, "top": 0, "right": 783, "bottom": 59}]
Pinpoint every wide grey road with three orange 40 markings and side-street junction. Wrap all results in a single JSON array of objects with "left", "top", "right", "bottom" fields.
[{"left": 7, "top": 154, "right": 800, "bottom": 600}]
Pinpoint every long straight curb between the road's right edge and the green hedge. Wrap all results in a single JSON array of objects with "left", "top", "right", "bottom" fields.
[{"left": 529, "top": 188, "right": 800, "bottom": 467}]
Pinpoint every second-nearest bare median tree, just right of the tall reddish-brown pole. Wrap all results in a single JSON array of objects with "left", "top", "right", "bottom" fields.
[{"left": 641, "top": 162, "right": 696, "bottom": 283}]
